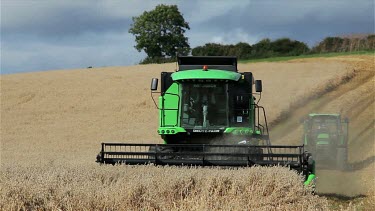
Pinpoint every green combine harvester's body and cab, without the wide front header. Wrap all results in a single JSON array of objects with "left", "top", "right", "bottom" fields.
[{"left": 151, "top": 57, "right": 270, "bottom": 148}]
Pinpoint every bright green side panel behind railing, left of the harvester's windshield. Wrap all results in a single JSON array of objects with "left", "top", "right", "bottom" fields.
[{"left": 159, "top": 83, "right": 180, "bottom": 127}]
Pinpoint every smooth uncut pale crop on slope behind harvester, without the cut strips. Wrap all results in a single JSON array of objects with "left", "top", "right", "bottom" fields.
[{"left": 1, "top": 57, "right": 350, "bottom": 163}]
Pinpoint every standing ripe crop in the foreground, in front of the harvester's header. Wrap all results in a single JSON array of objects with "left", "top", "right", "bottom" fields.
[{"left": 1, "top": 164, "right": 327, "bottom": 210}]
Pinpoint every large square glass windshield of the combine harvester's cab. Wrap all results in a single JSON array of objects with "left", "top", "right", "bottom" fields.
[{"left": 181, "top": 83, "right": 228, "bottom": 129}]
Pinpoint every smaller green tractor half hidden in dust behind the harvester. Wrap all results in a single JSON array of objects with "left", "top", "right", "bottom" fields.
[{"left": 303, "top": 114, "right": 349, "bottom": 170}]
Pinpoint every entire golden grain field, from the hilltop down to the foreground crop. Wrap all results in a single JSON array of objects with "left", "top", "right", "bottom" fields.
[{"left": 0, "top": 56, "right": 375, "bottom": 210}]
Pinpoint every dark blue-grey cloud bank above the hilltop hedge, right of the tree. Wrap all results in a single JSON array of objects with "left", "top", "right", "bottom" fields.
[{"left": 192, "top": 0, "right": 374, "bottom": 45}]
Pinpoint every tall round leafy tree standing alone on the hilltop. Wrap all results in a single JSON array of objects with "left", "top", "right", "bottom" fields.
[{"left": 129, "top": 4, "right": 190, "bottom": 63}]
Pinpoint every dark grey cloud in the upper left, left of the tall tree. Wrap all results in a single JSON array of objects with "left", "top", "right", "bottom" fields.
[{"left": 2, "top": 1, "right": 131, "bottom": 36}]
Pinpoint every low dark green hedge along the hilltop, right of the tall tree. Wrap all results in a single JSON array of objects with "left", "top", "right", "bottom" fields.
[{"left": 191, "top": 34, "right": 375, "bottom": 59}]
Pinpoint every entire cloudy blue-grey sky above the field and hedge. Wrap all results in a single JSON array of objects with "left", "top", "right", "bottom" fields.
[{"left": 0, "top": 0, "right": 374, "bottom": 74}]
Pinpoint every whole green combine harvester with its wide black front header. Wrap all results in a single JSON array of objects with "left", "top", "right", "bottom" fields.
[{"left": 97, "top": 57, "right": 315, "bottom": 184}]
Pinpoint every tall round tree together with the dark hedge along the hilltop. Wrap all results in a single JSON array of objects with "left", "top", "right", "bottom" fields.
[{"left": 129, "top": 4, "right": 375, "bottom": 64}]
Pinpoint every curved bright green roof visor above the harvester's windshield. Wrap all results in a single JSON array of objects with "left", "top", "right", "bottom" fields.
[{"left": 172, "top": 69, "right": 241, "bottom": 81}]
